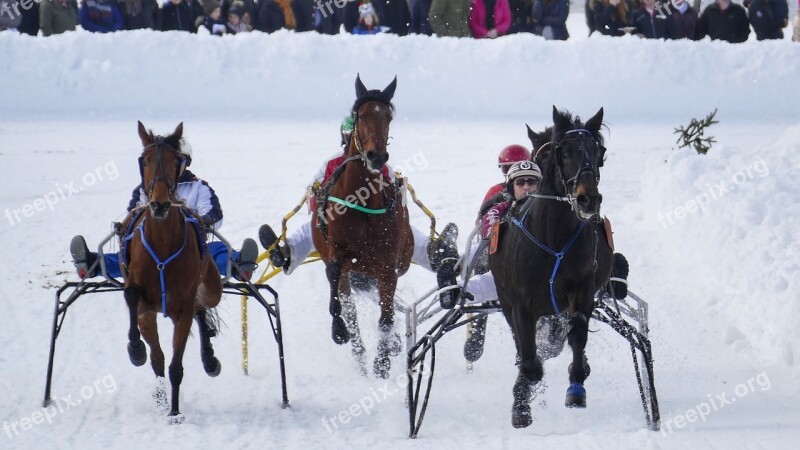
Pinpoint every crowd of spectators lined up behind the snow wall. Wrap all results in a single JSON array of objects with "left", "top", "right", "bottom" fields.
[{"left": 0, "top": 0, "right": 800, "bottom": 43}]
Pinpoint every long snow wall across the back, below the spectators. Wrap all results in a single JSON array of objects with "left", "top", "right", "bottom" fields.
[{"left": 0, "top": 31, "right": 800, "bottom": 120}]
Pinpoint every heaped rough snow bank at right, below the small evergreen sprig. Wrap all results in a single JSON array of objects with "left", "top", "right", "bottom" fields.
[{"left": 641, "top": 126, "right": 800, "bottom": 373}]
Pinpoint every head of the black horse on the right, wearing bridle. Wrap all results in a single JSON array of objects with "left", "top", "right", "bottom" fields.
[{"left": 529, "top": 106, "right": 606, "bottom": 220}]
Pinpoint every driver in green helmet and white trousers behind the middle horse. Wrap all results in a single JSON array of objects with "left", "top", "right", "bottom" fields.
[{"left": 258, "top": 114, "right": 458, "bottom": 275}]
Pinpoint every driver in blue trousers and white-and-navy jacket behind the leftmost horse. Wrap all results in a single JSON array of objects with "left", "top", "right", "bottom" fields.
[{"left": 70, "top": 138, "right": 258, "bottom": 281}]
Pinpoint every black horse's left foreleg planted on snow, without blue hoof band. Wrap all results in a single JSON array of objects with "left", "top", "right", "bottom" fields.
[{"left": 511, "top": 305, "right": 544, "bottom": 428}]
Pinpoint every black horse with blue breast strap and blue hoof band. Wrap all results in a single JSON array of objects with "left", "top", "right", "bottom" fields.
[{"left": 489, "top": 106, "right": 612, "bottom": 428}]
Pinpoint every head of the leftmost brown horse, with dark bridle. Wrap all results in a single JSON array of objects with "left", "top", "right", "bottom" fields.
[{"left": 139, "top": 122, "right": 186, "bottom": 220}]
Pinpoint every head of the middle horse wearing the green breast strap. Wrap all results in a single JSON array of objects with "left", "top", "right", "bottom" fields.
[{"left": 348, "top": 76, "right": 397, "bottom": 173}]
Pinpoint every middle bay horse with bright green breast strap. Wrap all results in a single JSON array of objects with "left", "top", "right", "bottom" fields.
[{"left": 312, "top": 76, "right": 414, "bottom": 378}]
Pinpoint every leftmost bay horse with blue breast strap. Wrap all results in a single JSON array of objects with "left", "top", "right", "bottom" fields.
[{"left": 121, "top": 122, "right": 222, "bottom": 423}]
